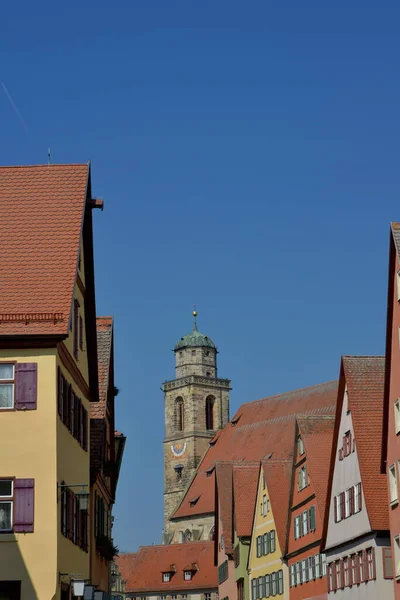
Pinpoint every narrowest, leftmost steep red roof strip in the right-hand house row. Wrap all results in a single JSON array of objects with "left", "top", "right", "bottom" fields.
[{"left": 215, "top": 462, "right": 233, "bottom": 554}]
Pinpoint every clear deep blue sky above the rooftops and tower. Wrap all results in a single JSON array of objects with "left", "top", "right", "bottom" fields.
[{"left": 0, "top": 0, "right": 400, "bottom": 551}]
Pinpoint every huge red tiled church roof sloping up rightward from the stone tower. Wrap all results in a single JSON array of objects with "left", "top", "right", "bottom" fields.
[{"left": 173, "top": 381, "right": 337, "bottom": 519}]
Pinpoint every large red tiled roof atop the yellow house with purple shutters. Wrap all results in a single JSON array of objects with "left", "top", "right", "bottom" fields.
[{"left": 0, "top": 164, "right": 89, "bottom": 335}]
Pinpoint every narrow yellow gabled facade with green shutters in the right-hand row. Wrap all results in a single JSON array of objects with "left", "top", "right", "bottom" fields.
[{"left": 248, "top": 462, "right": 289, "bottom": 600}]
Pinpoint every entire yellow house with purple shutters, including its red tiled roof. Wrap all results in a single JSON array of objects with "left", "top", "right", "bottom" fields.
[{"left": 0, "top": 165, "right": 104, "bottom": 600}]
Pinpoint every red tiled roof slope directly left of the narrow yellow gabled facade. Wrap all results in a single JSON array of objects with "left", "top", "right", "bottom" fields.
[{"left": 233, "top": 462, "right": 260, "bottom": 537}]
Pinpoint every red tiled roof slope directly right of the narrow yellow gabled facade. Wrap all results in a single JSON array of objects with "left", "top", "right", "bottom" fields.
[{"left": 262, "top": 459, "right": 292, "bottom": 552}]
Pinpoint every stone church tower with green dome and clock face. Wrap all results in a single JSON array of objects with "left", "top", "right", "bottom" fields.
[{"left": 163, "top": 311, "right": 231, "bottom": 538}]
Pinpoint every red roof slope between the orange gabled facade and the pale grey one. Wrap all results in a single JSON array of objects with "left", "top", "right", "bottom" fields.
[{"left": 297, "top": 415, "right": 335, "bottom": 519}]
